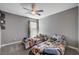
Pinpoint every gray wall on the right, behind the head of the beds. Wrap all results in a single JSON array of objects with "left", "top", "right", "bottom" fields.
[{"left": 39, "top": 7, "right": 78, "bottom": 47}]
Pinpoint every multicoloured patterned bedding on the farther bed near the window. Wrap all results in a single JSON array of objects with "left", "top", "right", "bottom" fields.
[{"left": 25, "top": 35, "right": 47, "bottom": 49}]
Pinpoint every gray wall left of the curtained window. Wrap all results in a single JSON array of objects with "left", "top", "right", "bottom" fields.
[{"left": 1, "top": 13, "right": 28, "bottom": 45}]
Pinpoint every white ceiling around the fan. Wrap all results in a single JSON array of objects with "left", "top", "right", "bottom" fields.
[{"left": 0, "top": 3, "right": 77, "bottom": 19}]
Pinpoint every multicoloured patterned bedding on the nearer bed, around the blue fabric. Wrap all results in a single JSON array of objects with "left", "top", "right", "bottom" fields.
[{"left": 31, "top": 41, "right": 66, "bottom": 55}]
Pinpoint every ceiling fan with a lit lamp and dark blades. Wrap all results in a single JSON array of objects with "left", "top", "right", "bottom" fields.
[{"left": 23, "top": 3, "right": 43, "bottom": 16}]
